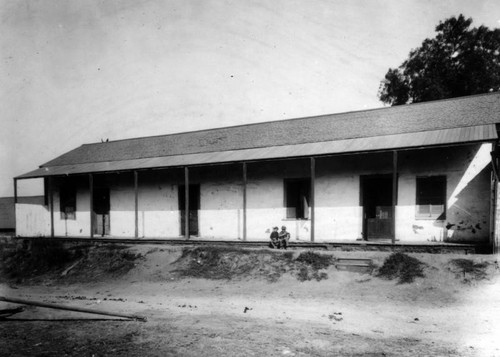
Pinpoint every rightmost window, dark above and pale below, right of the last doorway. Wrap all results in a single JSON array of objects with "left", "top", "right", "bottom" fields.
[{"left": 416, "top": 176, "right": 446, "bottom": 220}]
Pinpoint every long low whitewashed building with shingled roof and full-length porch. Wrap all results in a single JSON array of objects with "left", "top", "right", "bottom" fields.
[{"left": 14, "top": 92, "right": 500, "bottom": 249}]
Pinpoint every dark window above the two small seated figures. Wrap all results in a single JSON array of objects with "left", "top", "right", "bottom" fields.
[{"left": 285, "top": 178, "right": 310, "bottom": 219}]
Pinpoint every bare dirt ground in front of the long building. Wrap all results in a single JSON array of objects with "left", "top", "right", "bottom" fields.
[{"left": 0, "top": 246, "right": 500, "bottom": 356}]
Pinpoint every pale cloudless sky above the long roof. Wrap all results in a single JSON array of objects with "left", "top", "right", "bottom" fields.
[{"left": 0, "top": 0, "right": 500, "bottom": 197}]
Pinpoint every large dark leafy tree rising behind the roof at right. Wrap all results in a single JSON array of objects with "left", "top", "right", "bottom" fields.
[{"left": 378, "top": 15, "right": 500, "bottom": 105}]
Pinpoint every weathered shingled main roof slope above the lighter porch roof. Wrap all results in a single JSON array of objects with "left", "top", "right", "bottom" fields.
[{"left": 41, "top": 92, "right": 500, "bottom": 167}]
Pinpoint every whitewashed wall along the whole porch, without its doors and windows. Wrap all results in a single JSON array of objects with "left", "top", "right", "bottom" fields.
[{"left": 16, "top": 144, "right": 490, "bottom": 242}]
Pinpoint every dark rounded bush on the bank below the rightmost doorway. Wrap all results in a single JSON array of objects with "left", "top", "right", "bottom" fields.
[{"left": 377, "top": 253, "right": 425, "bottom": 284}]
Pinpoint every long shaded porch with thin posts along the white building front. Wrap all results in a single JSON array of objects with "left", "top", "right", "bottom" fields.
[{"left": 15, "top": 144, "right": 493, "bottom": 247}]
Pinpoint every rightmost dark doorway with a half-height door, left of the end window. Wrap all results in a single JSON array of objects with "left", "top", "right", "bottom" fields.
[{"left": 361, "top": 175, "right": 394, "bottom": 240}]
